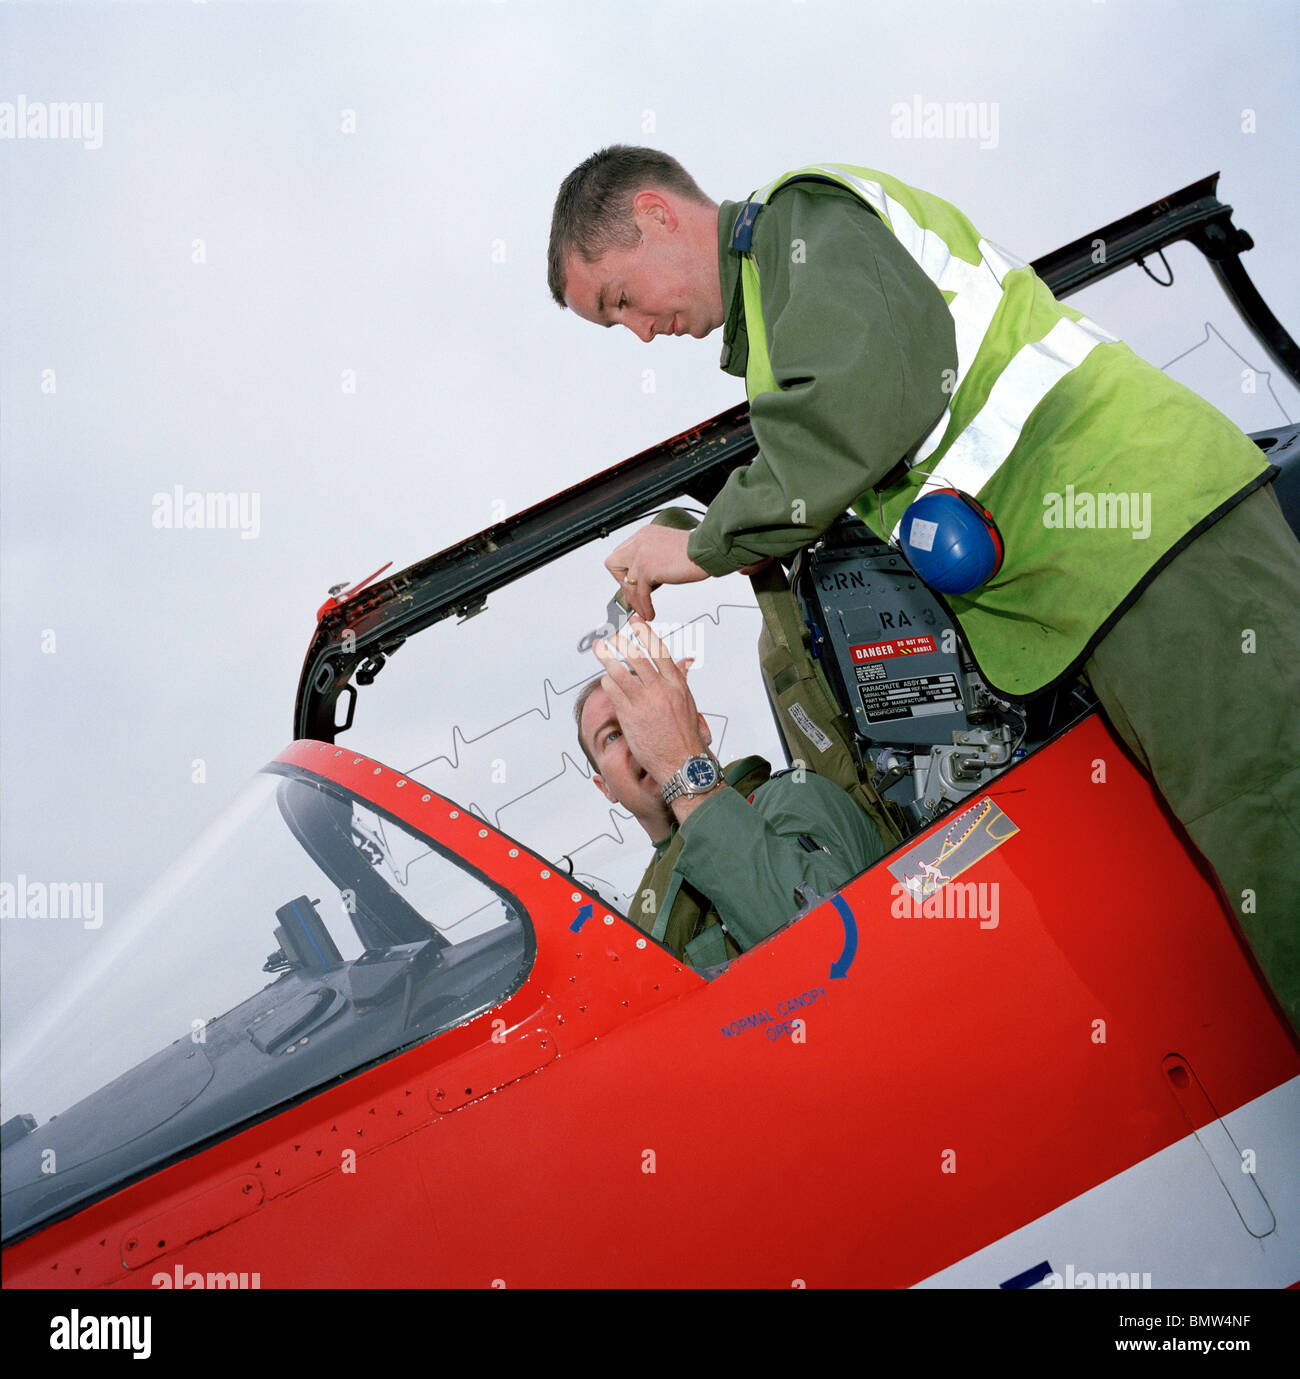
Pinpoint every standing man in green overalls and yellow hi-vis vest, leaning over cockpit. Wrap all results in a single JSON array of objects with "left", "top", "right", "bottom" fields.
[{"left": 549, "top": 146, "right": 1300, "bottom": 1027}]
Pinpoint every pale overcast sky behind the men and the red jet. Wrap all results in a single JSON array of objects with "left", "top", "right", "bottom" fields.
[{"left": 0, "top": 0, "right": 1300, "bottom": 1075}]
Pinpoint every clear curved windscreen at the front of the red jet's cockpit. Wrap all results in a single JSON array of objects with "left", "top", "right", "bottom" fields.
[{"left": 3, "top": 765, "right": 534, "bottom": 1237}]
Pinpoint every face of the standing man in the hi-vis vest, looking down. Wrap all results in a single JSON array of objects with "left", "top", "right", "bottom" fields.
[{"left": 565, "top": 192, "right": 724, "bottom": 343}]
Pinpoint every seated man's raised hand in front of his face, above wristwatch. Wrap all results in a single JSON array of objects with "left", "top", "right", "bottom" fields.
[{"left": 593, "top": 618, "right": 707, "bottom": 786}]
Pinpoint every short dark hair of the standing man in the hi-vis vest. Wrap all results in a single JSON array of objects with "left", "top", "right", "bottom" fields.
[{"left": 546, "top": 143, "right": 713, "bottom": 306}]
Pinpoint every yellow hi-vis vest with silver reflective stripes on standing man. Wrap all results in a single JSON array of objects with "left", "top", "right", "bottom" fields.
[{"left": 731, "top": 164, "right": 1272, "bottom": 698}]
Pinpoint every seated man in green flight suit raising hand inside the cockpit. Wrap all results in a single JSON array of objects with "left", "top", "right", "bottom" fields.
[{"left": 575, "top": 618, "right": 884, "bottom": 967}]
